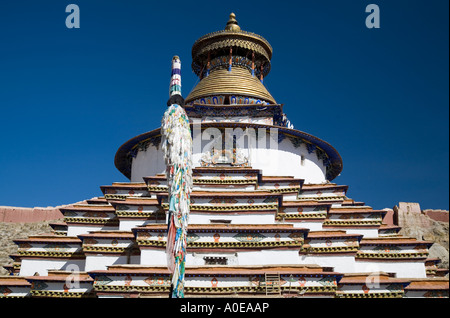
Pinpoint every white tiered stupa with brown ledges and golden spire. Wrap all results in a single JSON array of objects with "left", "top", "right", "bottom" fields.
[{"left": 0, "top": 14, "right": 449, "bottom": 298}]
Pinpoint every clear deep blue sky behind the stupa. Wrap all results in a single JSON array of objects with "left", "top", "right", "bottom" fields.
[{"left": 0, "top": 0, "right": 449, "bottom": 209}]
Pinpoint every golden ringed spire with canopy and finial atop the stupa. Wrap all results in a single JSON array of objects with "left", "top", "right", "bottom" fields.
[{"left": 185, "top": 13, "right": 276, "bottom": 104}]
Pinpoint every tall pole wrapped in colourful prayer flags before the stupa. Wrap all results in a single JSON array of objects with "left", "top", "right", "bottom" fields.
[{"left": 161, "top": 56, "right": 192, "bottom": 298}]
